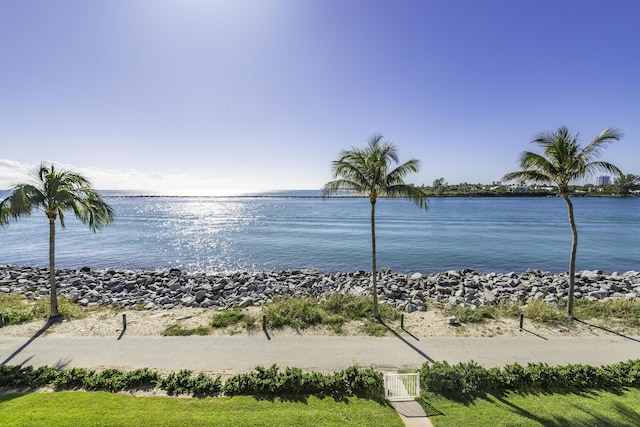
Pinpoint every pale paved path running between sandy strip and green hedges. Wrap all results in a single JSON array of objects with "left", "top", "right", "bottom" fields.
[{"left": 0, "top": 329, "right": 640, "bottom": 374}]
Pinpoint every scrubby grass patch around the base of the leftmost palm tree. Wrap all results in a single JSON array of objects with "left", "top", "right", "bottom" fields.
[{"left": 0, "top": 292, "right": 87, "bottom": 325}]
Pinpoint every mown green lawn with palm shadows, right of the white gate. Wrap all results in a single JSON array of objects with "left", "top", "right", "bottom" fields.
[{"left": 423, "top": 389, "right": 640, "bottom": 427}]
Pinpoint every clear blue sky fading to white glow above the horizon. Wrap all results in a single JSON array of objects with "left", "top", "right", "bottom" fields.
[{"left": 0, "top": 0, "right": 640, "bottom": 193}]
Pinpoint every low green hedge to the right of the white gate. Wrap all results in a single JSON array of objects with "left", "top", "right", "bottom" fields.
[{"left": 420, "top": 360, "right": 640, "bottom": 394}]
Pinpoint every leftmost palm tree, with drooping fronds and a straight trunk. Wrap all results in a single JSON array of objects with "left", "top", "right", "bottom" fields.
[{"left": 0, "top": 163, "right": 113, "bottom": 321}]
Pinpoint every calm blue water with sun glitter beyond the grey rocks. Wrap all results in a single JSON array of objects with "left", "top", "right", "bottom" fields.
[{"left": 0, "top": 191, "right": 640, "bottom": 273}]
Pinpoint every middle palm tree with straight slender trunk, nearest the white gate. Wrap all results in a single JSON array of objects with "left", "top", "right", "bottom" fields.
[{"left": 322, "top": 135, "right": 429, "bottom": 320}]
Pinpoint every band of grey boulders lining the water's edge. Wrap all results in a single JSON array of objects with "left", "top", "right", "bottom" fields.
[{"left": 0, "top": 265, "right": 640, "bottom": 312}]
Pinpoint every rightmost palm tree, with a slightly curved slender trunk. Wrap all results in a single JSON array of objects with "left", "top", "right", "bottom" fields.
[{"left": 503, "top": 126, "right": 622, "bottom": 317}]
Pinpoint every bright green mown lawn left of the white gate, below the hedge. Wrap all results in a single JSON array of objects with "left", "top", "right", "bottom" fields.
[{"left": 0, "top": 392, "right": 403, "bottom": 427}]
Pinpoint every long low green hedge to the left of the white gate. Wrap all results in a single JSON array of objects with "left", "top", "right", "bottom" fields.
[{"left": 0, "top": 365, "right": 383, "bottom": 399}]
